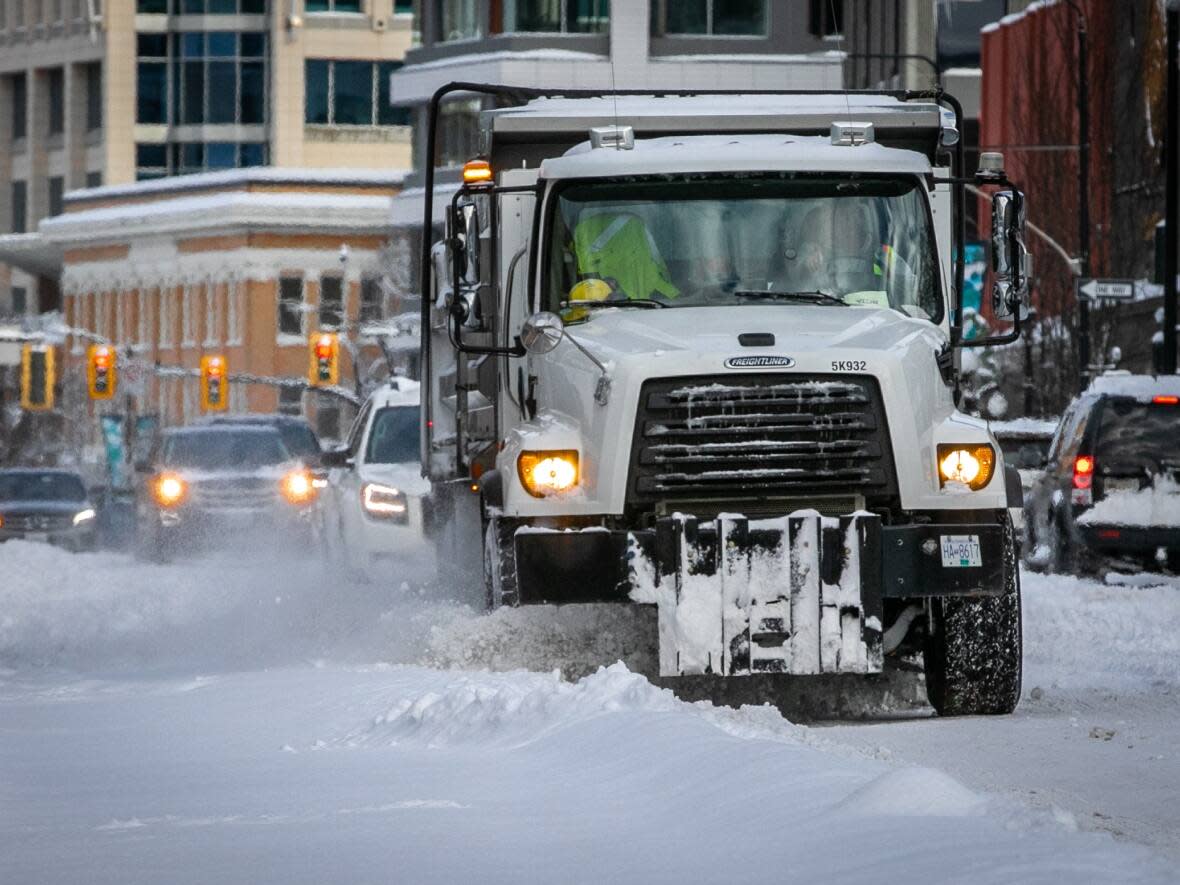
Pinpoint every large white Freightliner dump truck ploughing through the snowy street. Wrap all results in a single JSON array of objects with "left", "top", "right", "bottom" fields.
[{"left": 421, "top": 84, "right": 1028, "bottom": 714}]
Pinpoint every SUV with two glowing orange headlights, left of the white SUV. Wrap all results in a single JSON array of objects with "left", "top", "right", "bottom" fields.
[{"left": 136, "top": 424, "right": 319, "bottom": 561}]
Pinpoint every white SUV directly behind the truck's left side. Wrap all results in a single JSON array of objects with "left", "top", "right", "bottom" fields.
[{"left": 323, "top": 378, "right": 430, "bottom": 573}]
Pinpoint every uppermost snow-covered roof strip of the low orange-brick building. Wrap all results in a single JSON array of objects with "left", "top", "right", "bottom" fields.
[{"left": 66, "top": 166, "right": 409, "bottom": 203}]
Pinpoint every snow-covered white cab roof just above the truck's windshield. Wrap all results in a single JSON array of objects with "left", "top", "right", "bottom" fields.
[{"left": 540, "top": 135, "right": 930, "bottom": 179}]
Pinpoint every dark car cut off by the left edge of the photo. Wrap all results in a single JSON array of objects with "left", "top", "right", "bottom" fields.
[{"left": 0, "top": 467, "right": 96, "bottom": 550}]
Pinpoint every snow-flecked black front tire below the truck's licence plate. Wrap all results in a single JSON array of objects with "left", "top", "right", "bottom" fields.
[{"left": 923, "top": 523, "right": 1022, "bottom": 716}]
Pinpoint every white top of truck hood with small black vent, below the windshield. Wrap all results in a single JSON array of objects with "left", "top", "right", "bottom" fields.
[{"left": 568, "top": 304, "right": 945, "bottom": 360}]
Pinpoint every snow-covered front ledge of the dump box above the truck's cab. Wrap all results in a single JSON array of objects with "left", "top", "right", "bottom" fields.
[{"left": 484, "top": 92, "right": 943, "bottom": 136}]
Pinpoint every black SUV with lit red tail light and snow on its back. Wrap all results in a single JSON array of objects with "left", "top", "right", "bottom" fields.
[{"left": 1025, "top": 374, "right": 1180, "bottom": 572}]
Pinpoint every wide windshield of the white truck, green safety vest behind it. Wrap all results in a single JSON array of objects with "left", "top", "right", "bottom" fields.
[{"left": 548, "top": 173, "right": 943, "bottom": 322}]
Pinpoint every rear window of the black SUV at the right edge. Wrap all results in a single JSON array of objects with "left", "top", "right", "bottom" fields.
[{"left": 1094, "top": 398, "right": 1180, "bottom": 473}]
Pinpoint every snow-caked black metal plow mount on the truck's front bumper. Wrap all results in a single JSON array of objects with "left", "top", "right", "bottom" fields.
[{"left": 630, "top": 512, "right": 884, "bottom": 676}]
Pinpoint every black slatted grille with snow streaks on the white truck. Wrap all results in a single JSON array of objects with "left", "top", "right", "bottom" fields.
[{"left": 628, "top": 374, "right": 896, "bottom": 505}]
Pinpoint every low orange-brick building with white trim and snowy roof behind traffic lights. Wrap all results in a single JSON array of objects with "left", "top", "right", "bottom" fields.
[{"left": 41, "top": 169, "right": 417, "bottom": 438}]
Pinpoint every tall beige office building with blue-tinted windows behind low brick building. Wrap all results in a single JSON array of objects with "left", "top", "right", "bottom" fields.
[{"left": 0, "top": 0, "right": 413, "bottom": 316}]
